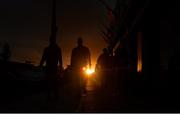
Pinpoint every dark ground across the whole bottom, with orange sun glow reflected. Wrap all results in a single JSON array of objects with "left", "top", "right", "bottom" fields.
[{"left": 0, "top": 72, "right": 179, "bottom": 112}]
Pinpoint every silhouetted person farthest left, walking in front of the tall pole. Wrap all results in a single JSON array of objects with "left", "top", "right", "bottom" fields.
[{"left": 40, "top": 38, "right": 63, "bottom": 98}]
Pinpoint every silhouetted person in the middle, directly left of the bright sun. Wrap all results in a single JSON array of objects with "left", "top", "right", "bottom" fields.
[{"left": 71, "top": 38, "right": 91, "bottom": 93}]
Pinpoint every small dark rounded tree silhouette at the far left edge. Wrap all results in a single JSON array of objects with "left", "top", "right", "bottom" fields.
[{"left": 1, "top": 43, "right": 11, "bottom": 61}]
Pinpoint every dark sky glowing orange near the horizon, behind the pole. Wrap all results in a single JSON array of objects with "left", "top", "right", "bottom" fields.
[{"left": 0, "top": 0, "right": 116, "bottom": 67}]
